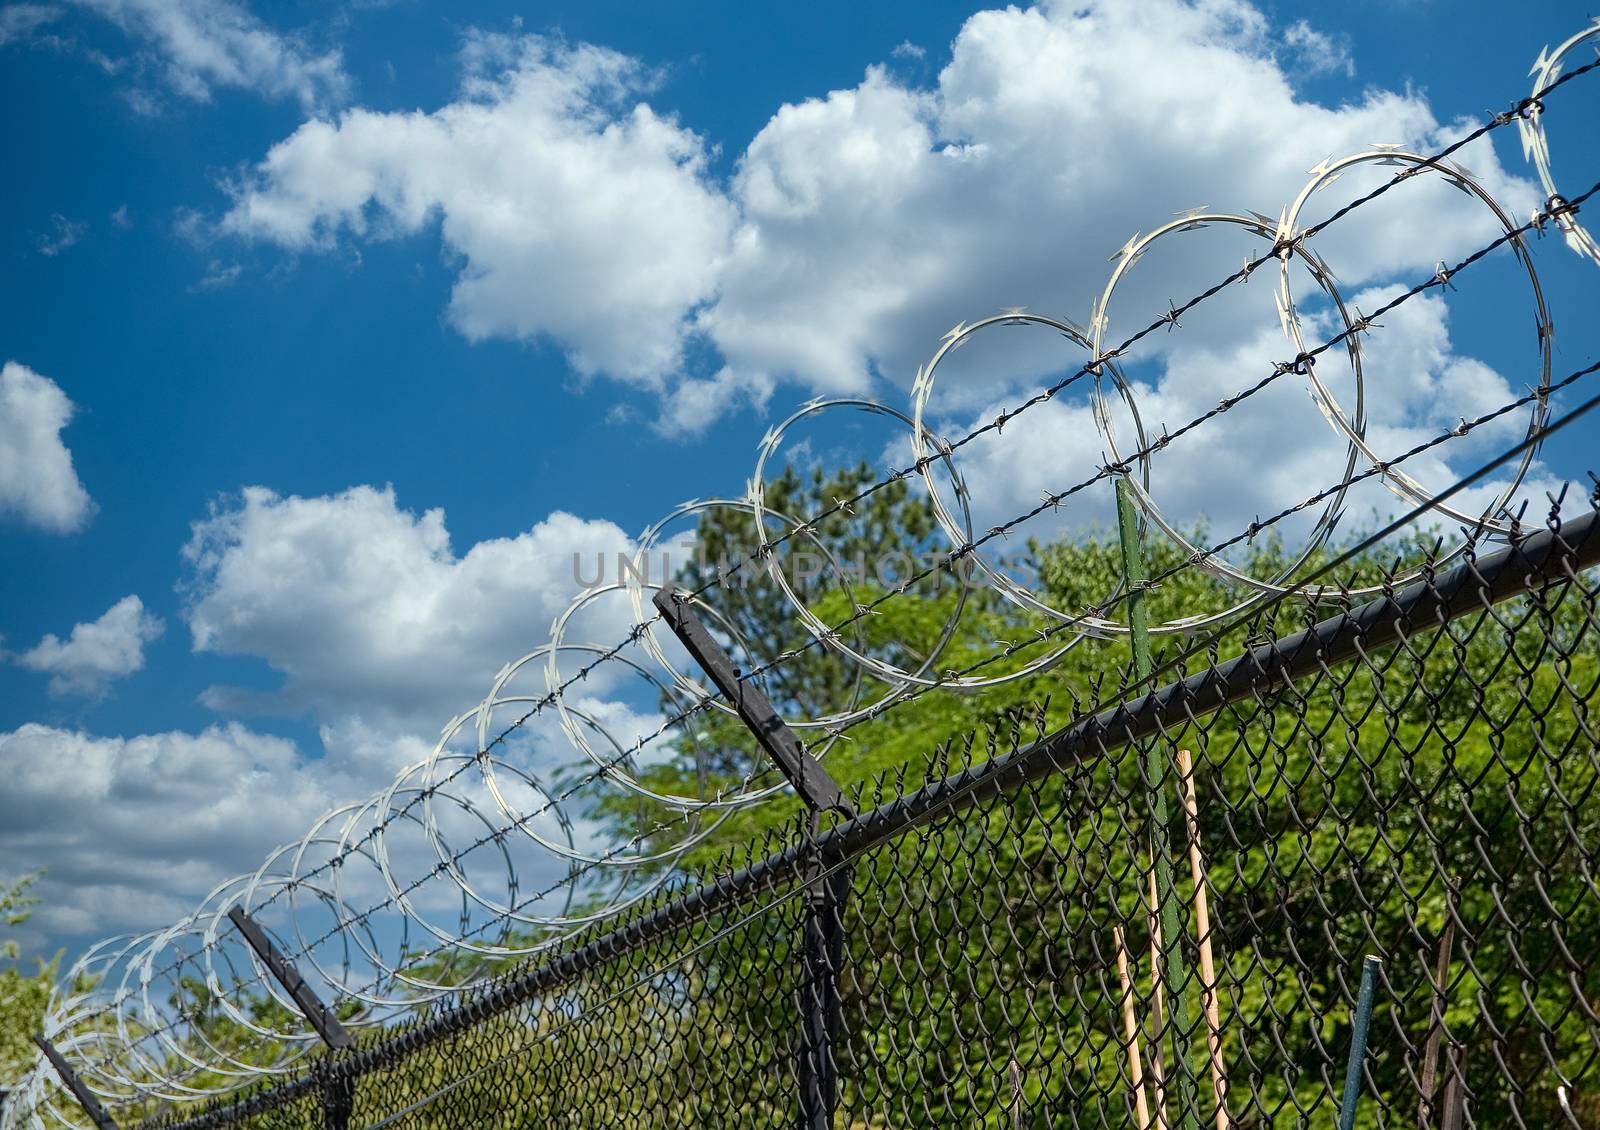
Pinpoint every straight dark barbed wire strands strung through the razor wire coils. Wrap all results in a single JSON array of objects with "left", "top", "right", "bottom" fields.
[{"left": 6, "top": 24, "right": 1600, "bottom": 1117}]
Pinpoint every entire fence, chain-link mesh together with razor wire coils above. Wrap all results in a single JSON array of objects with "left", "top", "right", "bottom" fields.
[{"left": 5, "top": 17, "right": 1600, "bottom": 1130}]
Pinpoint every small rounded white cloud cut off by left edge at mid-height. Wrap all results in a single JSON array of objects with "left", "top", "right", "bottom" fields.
[{"left": 0, "top": 362, "right": 94, "bottom": 533}]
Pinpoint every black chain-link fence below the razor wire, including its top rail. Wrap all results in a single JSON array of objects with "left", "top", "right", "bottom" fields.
[{"left": 134, "top": 512, "right": 1600, "bottom": 1130}]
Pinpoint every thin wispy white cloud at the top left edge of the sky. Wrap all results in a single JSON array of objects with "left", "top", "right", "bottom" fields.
[{"left": 77, "top": 0, "right": 350, "bottom": 112}]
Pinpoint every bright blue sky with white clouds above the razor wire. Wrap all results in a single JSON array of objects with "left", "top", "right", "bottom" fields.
[{"left": 0, "top": 0, "right": 1600, "bottom": 946}]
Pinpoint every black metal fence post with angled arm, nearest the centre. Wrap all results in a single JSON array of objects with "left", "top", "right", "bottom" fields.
[{"left": 654, "top": 584, "right": 854, "bottom": 1130}]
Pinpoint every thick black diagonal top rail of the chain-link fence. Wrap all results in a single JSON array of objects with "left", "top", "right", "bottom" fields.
[{"left": 141, "top": 509, "right": 1600, "bottom": 1130}]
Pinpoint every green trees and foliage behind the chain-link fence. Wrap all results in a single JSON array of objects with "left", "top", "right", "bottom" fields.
[{"left": 46, "top": 467, "right": 1600, "bottom": 1130}]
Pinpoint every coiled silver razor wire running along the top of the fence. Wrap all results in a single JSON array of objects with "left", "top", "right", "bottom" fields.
[{"left": 6, "top": 24, "right": 1600, "bottom": 1125}]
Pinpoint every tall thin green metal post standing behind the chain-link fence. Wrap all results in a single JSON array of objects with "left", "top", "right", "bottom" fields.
[{"left": 1117, "top": 475, "right": 1200, "bottom": 1130}]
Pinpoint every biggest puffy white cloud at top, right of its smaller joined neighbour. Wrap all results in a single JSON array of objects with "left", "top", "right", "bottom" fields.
[{"left": 699, "top": 0, "right": 1533, "bottom": 404}]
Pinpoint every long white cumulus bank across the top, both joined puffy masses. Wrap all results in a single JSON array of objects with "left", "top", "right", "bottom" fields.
[{"left": 222, "top": 0, "right": 1534, "bottom": 431}]
